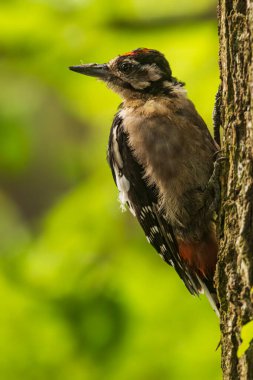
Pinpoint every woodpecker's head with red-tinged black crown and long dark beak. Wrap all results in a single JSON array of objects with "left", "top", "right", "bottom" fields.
[{"left": 70, "top": 48, "right": 183, "bottom": 99}]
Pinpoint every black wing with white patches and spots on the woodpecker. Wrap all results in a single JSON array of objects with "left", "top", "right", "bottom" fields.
[{"left": 107, "top": 114, "right": 202, "bottom": 294}]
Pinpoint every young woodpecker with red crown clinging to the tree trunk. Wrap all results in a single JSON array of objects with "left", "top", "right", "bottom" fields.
[{"left": 70, "top": 48, "right": 219, "bottom": 314}]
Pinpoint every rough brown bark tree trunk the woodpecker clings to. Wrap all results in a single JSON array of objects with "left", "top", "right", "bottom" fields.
[{"left": 216, "top": 0, "right": 253, "bottom": 380}]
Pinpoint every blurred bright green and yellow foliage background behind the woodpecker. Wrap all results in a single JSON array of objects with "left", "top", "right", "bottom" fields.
[{"left": 0, "top": 0, "right": 221, "bottom": 380}]
